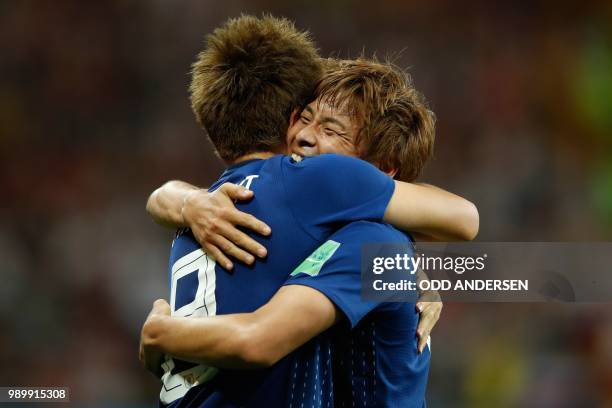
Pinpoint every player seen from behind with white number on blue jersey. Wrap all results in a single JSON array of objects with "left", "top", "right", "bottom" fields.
[{"left": 141, "top": 17, "right": 476, "bottom": 406}]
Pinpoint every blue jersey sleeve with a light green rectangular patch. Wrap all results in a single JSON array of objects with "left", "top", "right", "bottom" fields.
[{"left": 285, "top": 221, "right": 409, "bottom": 327}]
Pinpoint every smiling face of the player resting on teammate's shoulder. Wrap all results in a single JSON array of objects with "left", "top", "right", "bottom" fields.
[{"left": 287, "top": 99, "right": 360, "bottom": 156}]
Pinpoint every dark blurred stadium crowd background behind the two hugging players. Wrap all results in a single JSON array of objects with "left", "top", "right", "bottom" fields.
[{"left": 0, "top": 0, "right": 612, "bottom": 407}]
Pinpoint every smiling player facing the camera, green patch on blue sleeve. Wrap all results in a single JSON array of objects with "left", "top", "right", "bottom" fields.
[{"left": 143, "top": 60, "right": 448, "bottom": 406}]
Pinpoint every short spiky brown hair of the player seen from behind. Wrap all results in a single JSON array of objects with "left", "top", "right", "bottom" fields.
[{"left": 189, "top": 15, "right": 322, "bottom": 162}]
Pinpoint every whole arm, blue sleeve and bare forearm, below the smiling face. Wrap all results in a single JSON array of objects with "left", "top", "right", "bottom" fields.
[{"left": 283, "top": 154, "right": 478, "bottom": 241}]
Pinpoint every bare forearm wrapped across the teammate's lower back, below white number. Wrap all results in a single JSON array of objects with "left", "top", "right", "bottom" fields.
[{"left": 141, "top": 285, "right": 342, "bottom": 368}]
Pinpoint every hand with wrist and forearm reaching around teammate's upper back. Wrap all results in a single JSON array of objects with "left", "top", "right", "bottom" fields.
[{"left": 146, "top": 180, "right": 270, "bottom": 270}]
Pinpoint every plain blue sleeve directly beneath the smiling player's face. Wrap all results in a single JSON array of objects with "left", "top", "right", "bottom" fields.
[{"left": 283, "top": 154, "right": 395, "bottom": 238}]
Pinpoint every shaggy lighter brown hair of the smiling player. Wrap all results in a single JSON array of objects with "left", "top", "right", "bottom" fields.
[{"left": 316, "top": 57, "right": 435, "bottom": 181}]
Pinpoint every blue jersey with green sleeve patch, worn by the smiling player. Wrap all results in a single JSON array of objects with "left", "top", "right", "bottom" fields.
[{"left": 286, "top": 222, "right": 430, "bottom": 408}]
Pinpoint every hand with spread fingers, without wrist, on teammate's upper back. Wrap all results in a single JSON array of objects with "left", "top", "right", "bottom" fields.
[{"left": 182, "top": 183, "right": 271, "bottom": 270}]
